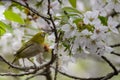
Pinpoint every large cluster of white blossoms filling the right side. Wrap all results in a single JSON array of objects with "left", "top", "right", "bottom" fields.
[{"left": 60, "top": 0, "right": 120, "bottom": 64}]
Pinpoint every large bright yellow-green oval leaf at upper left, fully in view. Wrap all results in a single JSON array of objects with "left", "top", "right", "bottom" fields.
[{"left": 4, "top": 10, "right": 25, "bottom": 24}]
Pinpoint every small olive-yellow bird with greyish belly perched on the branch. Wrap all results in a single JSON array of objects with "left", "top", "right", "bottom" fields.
[{"left": 9, "top": 31, "right": 46, "bottom": 68}]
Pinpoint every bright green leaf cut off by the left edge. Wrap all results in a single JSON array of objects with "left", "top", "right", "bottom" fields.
[{"left": 0, "top": 21, "right": 13, "bottom": 36}]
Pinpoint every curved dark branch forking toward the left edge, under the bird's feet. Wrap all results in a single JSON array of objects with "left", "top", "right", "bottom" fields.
[{"left": 0, "top": 54, "right": 56, "bottom": 76}]
